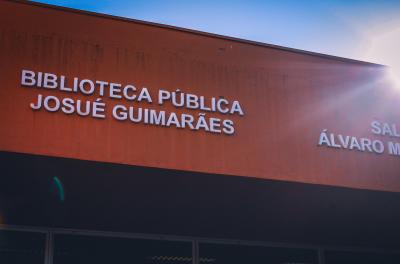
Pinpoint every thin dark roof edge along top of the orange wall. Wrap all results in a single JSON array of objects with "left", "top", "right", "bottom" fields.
[{"left": 18, "top": 0, "right": 387, "bottom": 67}]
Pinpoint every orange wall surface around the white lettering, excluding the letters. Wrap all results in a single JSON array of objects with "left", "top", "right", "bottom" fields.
[{"left": 0, "top": 1, "right": 400, "bottom": 191}]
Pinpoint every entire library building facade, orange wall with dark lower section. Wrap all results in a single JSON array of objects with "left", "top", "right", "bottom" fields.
[{"left": 0, "top": 0, "right": 400, "bottom": 264}]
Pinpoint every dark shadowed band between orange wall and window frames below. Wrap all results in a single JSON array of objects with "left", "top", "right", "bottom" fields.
[{"left": 0, "top": 152, "right": 400, "bottom": 250}]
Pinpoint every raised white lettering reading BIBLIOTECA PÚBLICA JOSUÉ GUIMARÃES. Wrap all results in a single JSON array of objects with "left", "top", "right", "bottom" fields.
[{"left": 21, "top": 70, "right": 244, "bottom": 135}]
